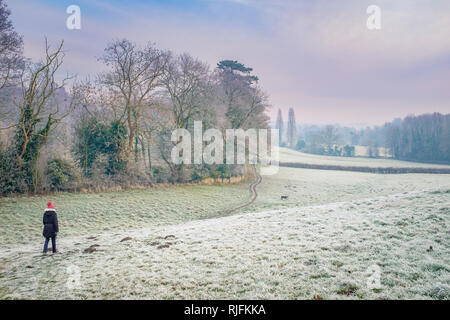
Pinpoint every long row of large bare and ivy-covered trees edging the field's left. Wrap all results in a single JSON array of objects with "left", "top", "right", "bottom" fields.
[{"left": 0, "top": 0, "right": 269, "bottom": 194}]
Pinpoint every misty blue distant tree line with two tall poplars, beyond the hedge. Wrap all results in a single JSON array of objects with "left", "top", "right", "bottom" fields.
[{"left": 275, "top": 108, "right": 450, "bottom": 163}]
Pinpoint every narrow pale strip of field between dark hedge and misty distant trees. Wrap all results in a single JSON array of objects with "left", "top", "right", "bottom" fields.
[{"left": 280, "top": 148, "right": 450, "bottom": 168}]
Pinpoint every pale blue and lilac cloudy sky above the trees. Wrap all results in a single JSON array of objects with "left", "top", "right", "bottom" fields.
[{"left": 6, "top": 0, "right": 450, "bottom": 125}]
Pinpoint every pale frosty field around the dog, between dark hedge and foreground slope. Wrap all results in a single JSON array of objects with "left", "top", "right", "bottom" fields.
[{"left": 244, "top": 167, "right": 450, "bottom": 212}]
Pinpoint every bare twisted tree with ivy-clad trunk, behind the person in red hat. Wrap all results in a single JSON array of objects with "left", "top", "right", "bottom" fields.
[{"left": 3, "top": 39, "right": 71, "bottom": 191}]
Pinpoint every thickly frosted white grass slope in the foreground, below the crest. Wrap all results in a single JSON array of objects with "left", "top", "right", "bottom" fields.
[{"left": 0, "top": 189, "right": 450, "bottom": 299}]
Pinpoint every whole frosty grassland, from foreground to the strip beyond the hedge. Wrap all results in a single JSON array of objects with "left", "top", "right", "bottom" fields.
[{"left": 0, "top": 150, "right": 450, "bottom": 299}]
